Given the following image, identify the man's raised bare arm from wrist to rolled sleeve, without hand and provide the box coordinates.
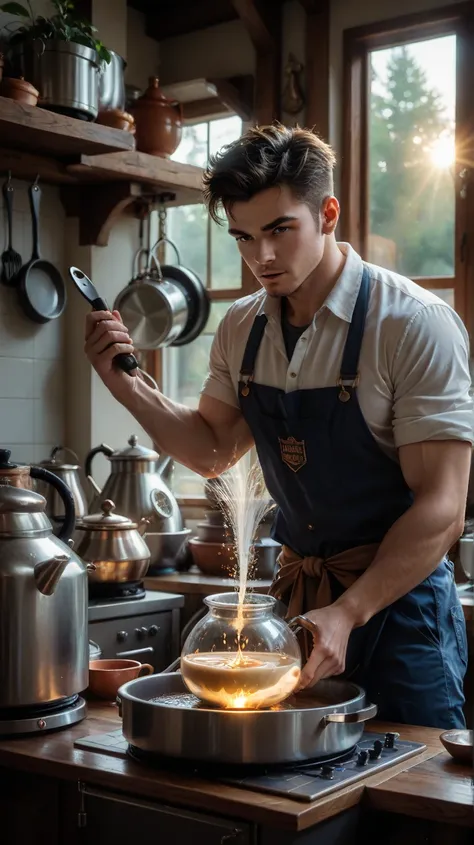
[123,379,253,478]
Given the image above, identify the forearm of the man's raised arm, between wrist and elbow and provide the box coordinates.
[120,378,219,476]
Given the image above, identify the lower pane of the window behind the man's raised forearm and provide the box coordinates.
[163,302,231,498]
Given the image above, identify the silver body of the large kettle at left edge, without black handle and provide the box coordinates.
[0,485,89,709]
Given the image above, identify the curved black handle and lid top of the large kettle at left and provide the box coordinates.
[0,449,76,542]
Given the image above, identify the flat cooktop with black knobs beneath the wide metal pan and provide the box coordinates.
[74,730,426,802]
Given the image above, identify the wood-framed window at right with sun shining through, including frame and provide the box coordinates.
[343,4,474,319]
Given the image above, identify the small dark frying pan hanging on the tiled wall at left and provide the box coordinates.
[16,177,66,323]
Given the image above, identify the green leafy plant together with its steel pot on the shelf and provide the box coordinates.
[0,0,110,120]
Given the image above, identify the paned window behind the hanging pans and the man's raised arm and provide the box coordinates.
[162,116,247,499]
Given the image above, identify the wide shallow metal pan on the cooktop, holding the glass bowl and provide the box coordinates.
[119,673,377,764]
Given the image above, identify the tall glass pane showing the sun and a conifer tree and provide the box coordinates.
[368,35,456,276]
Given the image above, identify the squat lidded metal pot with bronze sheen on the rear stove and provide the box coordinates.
[76,499,150,583]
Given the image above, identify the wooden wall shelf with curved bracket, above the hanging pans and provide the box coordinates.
[0,97,202,246]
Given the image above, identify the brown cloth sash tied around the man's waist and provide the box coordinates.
[269,543,379,619]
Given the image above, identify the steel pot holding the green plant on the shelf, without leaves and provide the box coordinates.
[9,39,101,120]
